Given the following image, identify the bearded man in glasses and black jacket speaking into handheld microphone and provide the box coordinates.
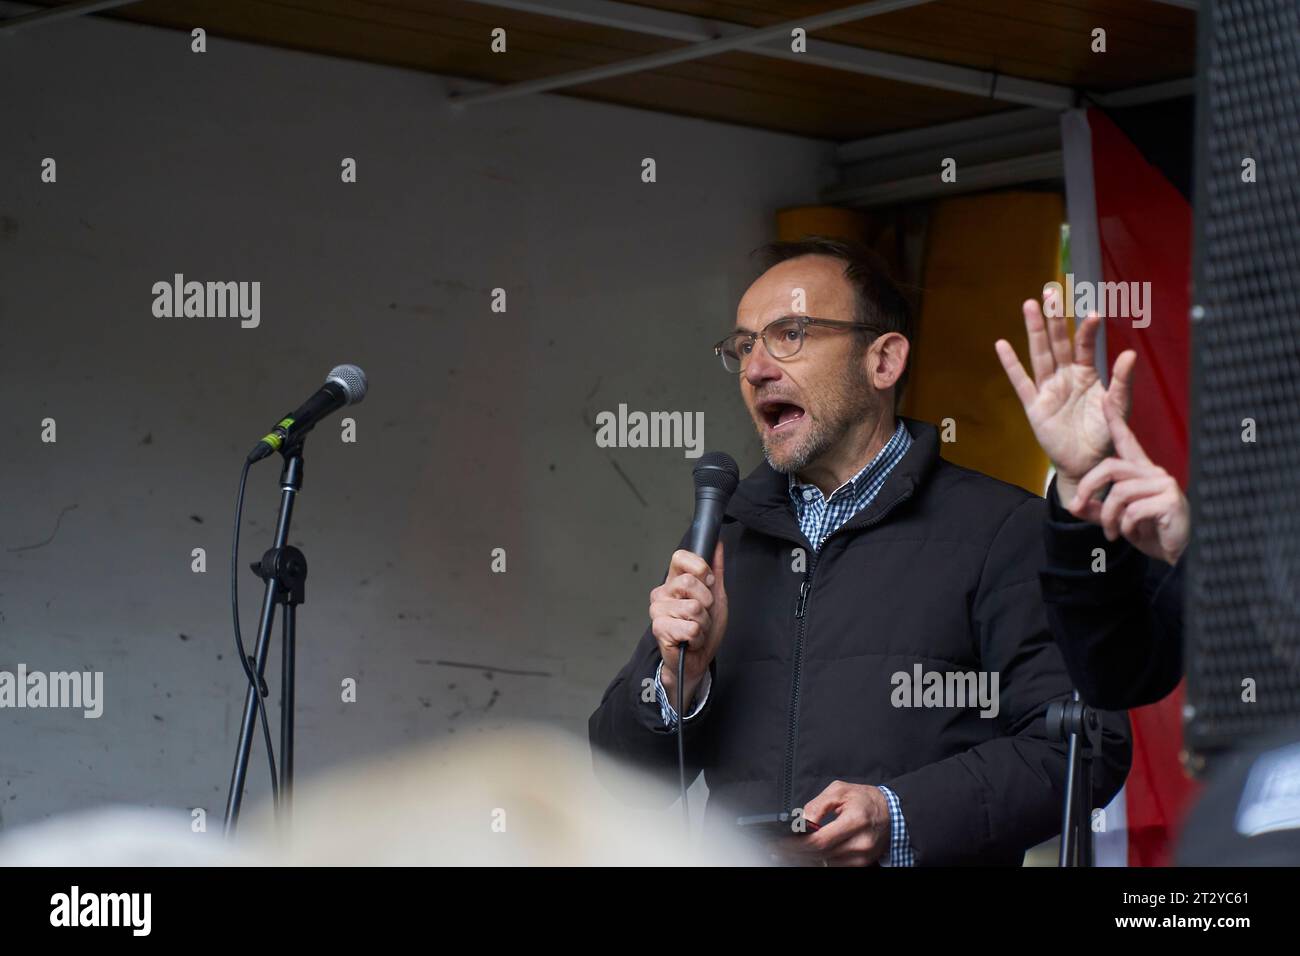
[589,237,1130,866]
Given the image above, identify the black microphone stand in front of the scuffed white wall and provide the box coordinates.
[225,432,307,836]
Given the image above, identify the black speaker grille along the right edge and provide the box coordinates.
[1186,0,1300,756]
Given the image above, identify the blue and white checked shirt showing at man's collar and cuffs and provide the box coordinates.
[654,421,917,866]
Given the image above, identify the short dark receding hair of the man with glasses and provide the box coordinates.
[754,235,913,405]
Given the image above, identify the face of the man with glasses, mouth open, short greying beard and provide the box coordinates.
[736,255,881,473]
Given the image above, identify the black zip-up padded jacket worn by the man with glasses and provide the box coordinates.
[589,419,1131,865]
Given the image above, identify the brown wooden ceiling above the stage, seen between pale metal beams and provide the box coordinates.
[14,0,1196,140]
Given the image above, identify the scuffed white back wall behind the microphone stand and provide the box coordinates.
[0,4,829,826]
